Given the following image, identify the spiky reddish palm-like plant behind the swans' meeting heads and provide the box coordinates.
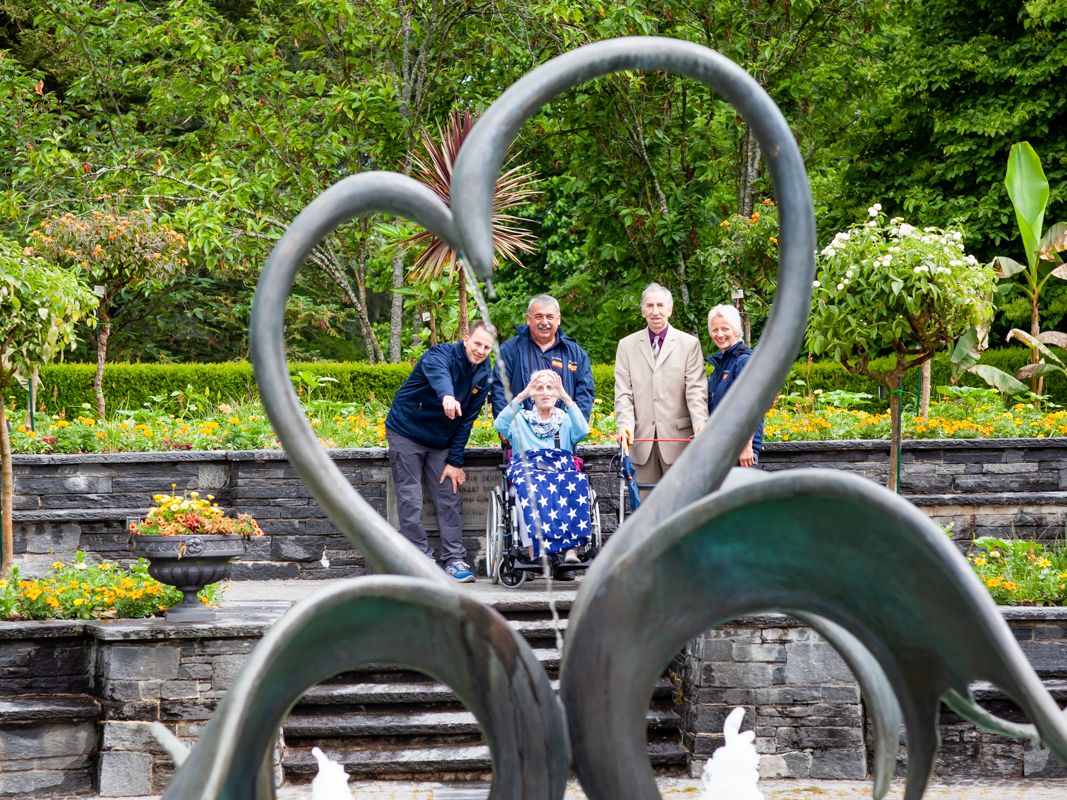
[400,111,539,343]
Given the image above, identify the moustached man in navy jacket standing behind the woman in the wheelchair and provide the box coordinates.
[492,294,593,420]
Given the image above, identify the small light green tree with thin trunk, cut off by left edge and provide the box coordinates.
[0,237,96,577]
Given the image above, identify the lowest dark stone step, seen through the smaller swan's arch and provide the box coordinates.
[282,741,686,780]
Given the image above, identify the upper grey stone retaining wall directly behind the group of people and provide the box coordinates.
[14,438,1067,580]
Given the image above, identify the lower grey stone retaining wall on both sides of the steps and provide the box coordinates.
[0,606,1067,798]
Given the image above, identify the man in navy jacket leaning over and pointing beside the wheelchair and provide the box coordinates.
[385,320,493,583]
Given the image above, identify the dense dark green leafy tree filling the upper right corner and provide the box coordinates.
[827,0,1067,260]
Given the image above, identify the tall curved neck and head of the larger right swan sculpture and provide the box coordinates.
[451,36,815,550]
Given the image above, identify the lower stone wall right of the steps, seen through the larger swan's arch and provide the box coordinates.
[674,608,1067,780]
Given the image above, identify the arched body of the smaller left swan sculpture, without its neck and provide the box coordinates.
[163,576,570,800]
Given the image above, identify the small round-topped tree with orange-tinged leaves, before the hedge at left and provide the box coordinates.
[30,210,189,417]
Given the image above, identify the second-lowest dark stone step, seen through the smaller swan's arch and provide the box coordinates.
[284,708,679,745]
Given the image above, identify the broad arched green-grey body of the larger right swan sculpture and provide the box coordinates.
[561,469,1067,800]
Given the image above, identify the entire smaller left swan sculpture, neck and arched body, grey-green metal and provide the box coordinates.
[157,173,570,800]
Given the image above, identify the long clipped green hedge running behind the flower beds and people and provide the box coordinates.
[10,348,1067,415]
